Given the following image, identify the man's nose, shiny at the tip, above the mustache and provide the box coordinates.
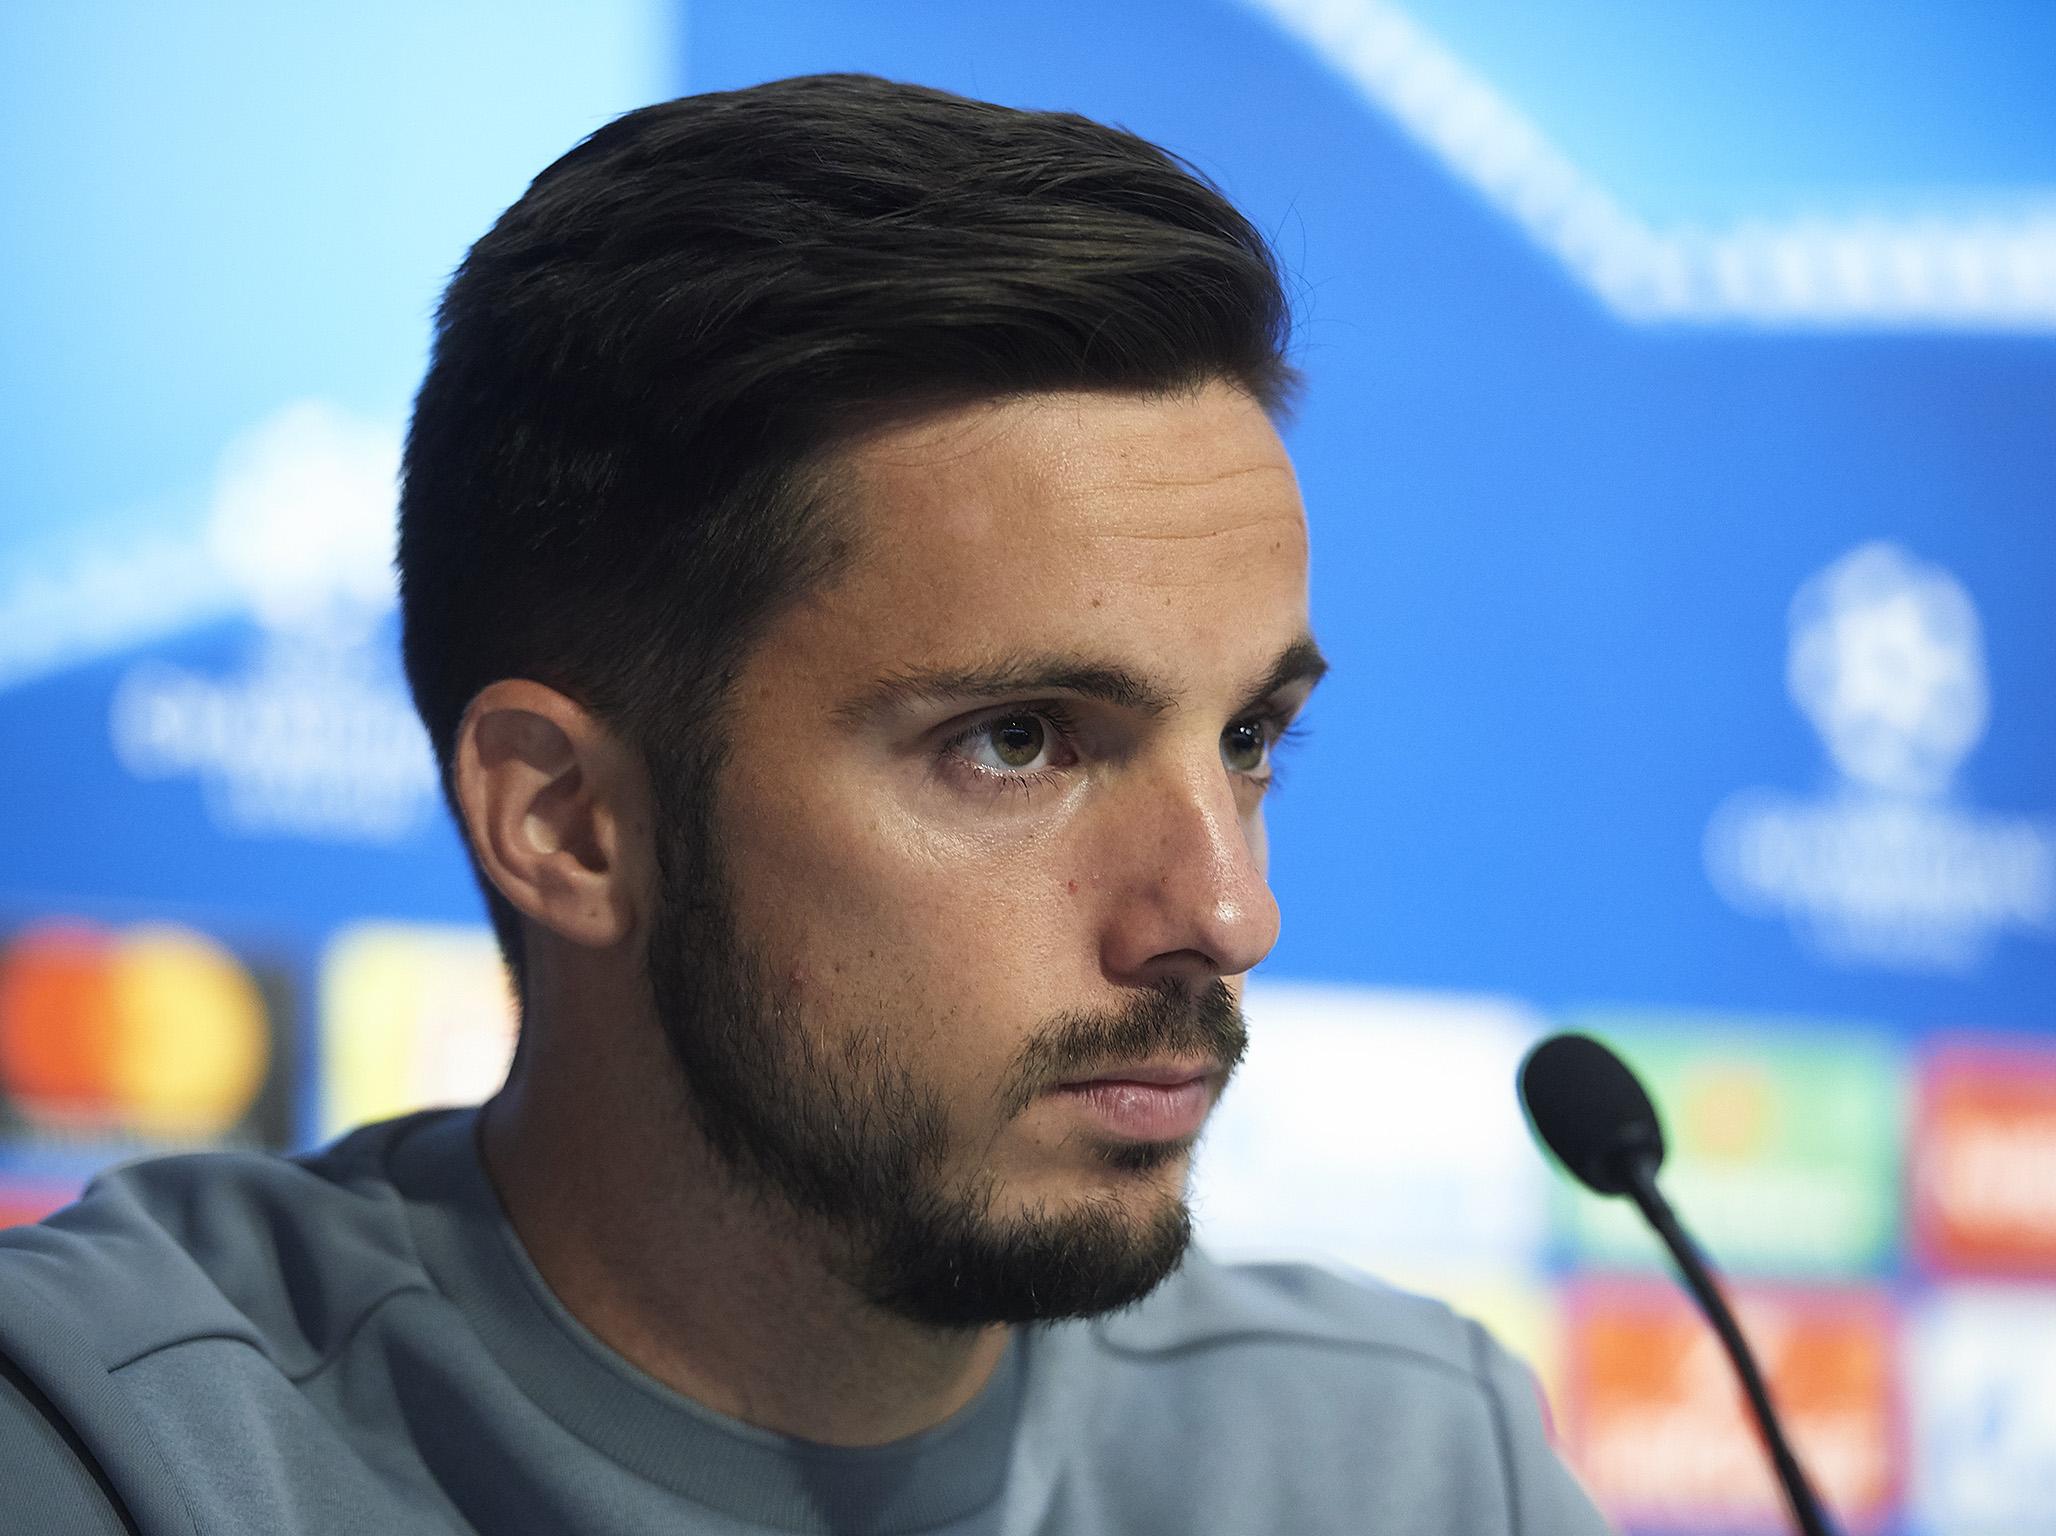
[1100,748,1279,987]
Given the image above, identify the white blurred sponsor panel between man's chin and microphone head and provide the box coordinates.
[1195,983,1548,1273]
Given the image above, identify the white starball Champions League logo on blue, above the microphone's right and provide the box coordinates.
[1706,543,2056,973]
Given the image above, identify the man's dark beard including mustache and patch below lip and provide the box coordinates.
[648,785,1246,1328]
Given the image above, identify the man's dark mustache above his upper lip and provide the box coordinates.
[990,977,1250,1114]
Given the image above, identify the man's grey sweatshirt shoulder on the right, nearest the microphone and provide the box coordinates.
[1032,1254,1606,1536]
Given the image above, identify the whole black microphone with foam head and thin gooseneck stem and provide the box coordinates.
[1519,1034,1834,1536]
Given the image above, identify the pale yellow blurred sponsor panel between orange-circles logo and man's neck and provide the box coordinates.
[321,923,516,1135]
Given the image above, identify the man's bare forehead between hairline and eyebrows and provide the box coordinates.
[802,385,1306,662]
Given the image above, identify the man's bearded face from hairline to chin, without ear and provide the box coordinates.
[650,385,1320,1324]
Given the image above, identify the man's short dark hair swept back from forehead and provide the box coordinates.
[399,74,1295,979]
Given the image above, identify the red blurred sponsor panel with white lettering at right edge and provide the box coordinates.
[1912,1043,2056,1274]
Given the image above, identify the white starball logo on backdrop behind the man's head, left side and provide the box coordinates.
[109,401,436,843]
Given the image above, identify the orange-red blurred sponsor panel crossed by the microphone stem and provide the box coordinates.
[1565,1281,1900,1530]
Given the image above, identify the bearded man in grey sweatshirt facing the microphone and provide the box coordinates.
[0,78,1600,1536]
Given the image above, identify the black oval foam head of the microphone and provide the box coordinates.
[1519,1034,1663,1195]
